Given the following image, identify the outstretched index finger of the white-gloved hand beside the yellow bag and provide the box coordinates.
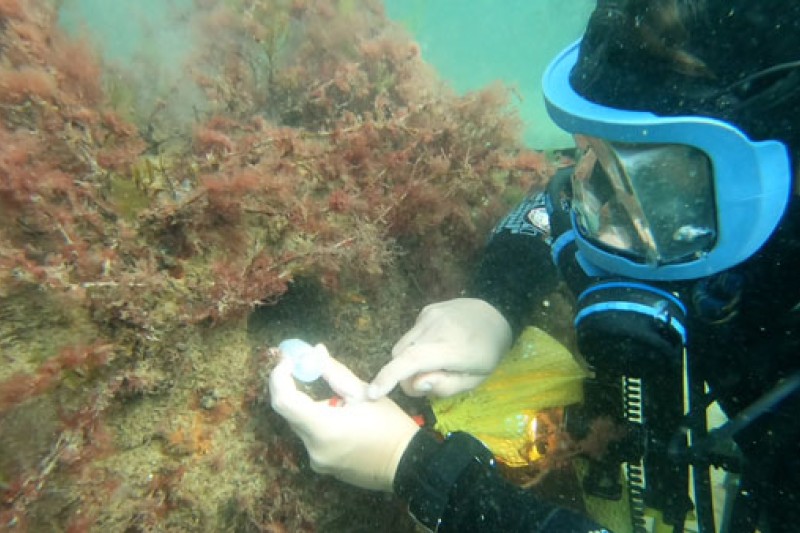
[367,342,469,400]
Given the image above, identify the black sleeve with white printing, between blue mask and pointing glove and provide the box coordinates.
[466,192,558,337]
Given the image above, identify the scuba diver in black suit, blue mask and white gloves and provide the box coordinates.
[270,0,800,533]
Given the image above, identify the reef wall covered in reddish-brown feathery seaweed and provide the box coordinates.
[0,0,551,532]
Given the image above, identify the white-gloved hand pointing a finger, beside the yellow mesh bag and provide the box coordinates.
[367,298,512,399]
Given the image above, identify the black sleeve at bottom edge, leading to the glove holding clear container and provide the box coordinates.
[394,430,608,533]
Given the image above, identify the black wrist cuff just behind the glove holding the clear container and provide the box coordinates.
[394,430,494,531]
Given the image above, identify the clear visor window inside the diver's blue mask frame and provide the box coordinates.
[572,135,717,265]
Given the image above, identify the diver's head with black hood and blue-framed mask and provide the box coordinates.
[544,0,800,280]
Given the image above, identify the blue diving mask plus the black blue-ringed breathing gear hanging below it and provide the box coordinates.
[543,38,791,529]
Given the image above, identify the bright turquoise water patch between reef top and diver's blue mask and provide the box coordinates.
[385,0,595,148]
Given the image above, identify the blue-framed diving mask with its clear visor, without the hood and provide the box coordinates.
[543,42,792,281]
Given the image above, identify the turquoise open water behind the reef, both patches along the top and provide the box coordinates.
[61,0,595,149]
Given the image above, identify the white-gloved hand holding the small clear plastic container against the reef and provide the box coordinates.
[269,344,419,492]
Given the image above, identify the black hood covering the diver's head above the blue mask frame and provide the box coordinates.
[570,0,800,154]
